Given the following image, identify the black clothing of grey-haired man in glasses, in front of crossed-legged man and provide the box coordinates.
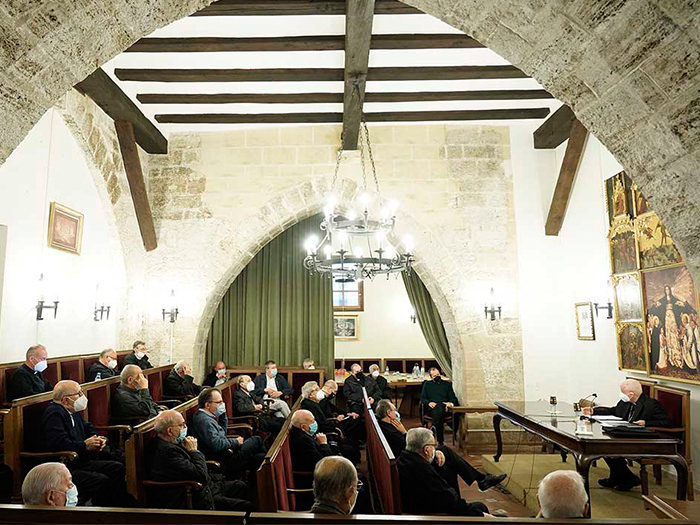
[396,450,488,516]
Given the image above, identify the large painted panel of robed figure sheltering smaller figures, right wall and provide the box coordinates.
[642,265,700,384]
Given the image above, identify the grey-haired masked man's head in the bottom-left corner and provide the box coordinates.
[22,463,78,507]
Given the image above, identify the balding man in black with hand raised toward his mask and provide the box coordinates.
[146,410,252,512]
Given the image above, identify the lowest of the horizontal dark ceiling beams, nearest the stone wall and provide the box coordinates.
[155,108,549,124]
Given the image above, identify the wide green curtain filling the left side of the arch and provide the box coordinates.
[207,215,334,370]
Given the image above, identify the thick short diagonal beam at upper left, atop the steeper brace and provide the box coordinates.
[75,68,168,154]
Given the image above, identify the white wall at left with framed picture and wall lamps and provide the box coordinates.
[0,110,125,362]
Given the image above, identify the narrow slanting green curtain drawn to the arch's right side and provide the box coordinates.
[401,271,452,377]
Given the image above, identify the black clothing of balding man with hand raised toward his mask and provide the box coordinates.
[146,437,252,511]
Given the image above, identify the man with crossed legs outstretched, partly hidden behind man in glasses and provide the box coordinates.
[375,399,507,494]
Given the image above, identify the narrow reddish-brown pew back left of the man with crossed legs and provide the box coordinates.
[362,388,401,514]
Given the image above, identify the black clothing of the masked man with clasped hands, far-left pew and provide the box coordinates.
[42,401,126,507]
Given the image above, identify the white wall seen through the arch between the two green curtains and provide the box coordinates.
[335,277,432,359]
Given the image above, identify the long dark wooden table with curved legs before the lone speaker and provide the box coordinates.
[493,401,688,516]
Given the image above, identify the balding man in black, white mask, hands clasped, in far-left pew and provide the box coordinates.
[42,381,126,507]
